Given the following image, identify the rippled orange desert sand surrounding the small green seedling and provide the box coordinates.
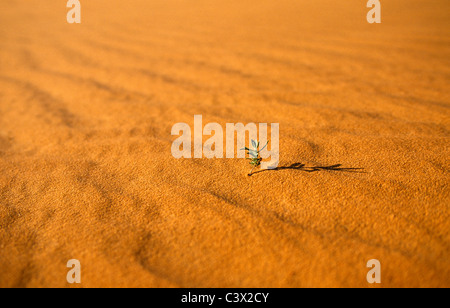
[0,0,450,287]
